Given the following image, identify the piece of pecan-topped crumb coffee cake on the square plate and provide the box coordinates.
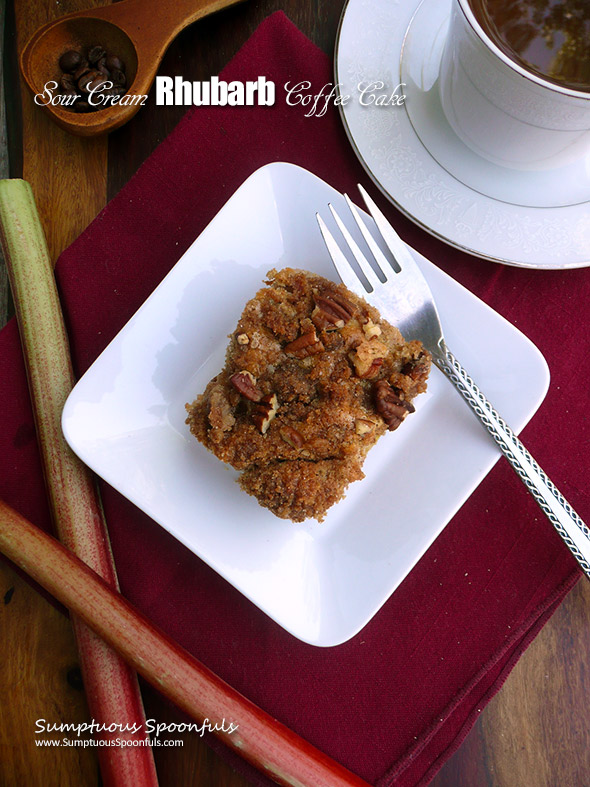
[187,268,431,522]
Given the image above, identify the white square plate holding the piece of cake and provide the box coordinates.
[63,163,549,646]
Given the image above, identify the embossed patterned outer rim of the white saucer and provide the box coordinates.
[335,0,590,269]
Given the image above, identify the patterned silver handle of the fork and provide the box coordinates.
[433,341,590,579]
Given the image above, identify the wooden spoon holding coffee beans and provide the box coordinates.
[21,0,247,136]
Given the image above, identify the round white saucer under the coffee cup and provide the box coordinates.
[335,0,590,269]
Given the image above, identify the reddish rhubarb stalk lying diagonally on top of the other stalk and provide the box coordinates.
[0,501,368,787]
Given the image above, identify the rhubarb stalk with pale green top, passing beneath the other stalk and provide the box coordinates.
[0,180,157,787]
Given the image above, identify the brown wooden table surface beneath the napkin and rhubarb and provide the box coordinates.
[0,0,590,787]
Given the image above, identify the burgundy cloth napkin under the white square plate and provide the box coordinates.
[0,13,590,787]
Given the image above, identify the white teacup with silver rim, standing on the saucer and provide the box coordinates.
[439,0,590,170]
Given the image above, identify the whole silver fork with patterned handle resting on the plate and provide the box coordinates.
[316,185,590,579]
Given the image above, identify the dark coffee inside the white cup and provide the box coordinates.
[469,0,590,92]
